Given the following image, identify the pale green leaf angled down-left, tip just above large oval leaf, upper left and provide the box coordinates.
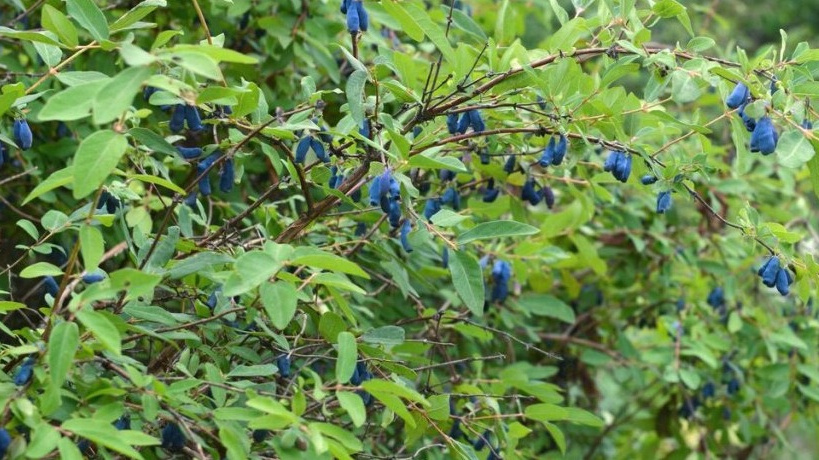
[93,67,154,125]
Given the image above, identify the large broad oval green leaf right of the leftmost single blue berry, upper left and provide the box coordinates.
[73,129,128,198]
